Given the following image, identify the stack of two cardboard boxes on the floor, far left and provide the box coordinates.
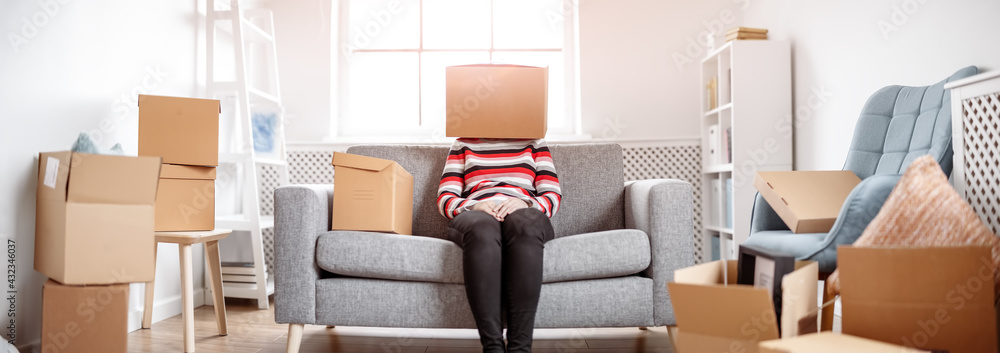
[35,151,160,352]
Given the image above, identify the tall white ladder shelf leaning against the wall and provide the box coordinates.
[205,0,288,309]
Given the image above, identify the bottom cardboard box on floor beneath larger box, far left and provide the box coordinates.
[41,279,128,353]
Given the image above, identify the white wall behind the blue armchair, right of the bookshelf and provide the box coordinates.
[743,0,1000,170]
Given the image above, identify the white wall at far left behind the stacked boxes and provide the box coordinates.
[0,0,201,346]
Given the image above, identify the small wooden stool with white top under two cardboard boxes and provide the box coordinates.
[142,229,232,353]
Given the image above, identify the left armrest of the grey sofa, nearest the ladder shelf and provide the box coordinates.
[274,185,333,324]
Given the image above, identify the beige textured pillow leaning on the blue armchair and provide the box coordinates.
[827,155,1000,294]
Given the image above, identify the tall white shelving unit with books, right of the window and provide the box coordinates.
[700,40,794,261]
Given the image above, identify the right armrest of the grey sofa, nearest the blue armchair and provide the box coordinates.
[625,179,694,326]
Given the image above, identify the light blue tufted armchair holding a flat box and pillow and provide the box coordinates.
[746,66,979,330]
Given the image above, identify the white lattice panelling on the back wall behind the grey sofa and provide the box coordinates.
[282,145,704,261]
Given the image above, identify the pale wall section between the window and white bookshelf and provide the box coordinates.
[579,0,746,139]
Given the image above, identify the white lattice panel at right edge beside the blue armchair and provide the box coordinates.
[956,93,1000,233]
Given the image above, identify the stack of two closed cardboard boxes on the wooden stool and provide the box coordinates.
[139,95,220,231]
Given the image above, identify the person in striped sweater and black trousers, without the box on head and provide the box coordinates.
[437,138,562,353]
